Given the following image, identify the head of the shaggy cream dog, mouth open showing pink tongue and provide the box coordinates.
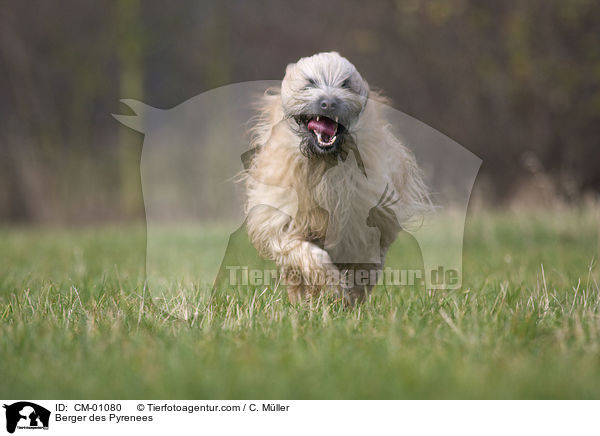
[281,52,369,156]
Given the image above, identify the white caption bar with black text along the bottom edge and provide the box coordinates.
[0,400,600,436]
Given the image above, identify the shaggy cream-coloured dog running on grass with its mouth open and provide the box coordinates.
[244,52,430,303]
